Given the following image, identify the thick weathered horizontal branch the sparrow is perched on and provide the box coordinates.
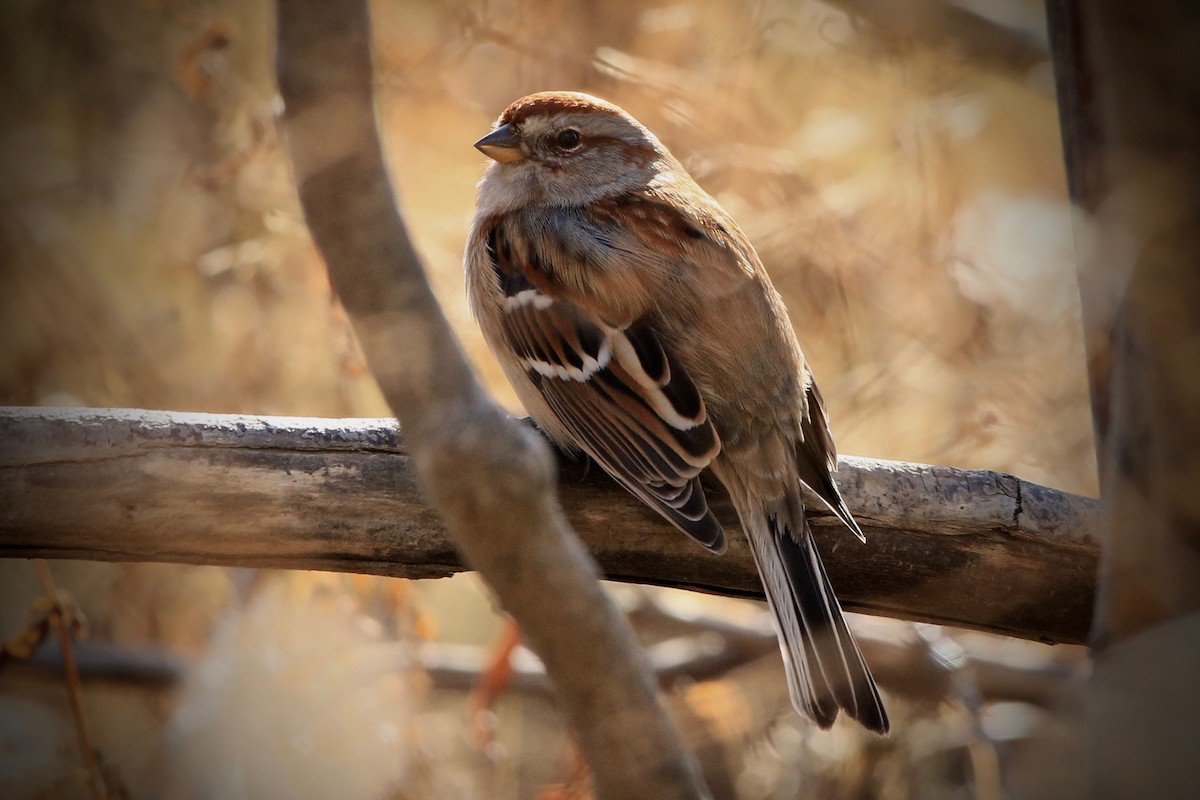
[0,408,1100,644]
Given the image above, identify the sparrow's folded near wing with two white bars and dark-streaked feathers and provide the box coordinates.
[488,220,725,552]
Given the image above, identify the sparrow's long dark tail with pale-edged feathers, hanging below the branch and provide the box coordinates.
[742,501,888,734]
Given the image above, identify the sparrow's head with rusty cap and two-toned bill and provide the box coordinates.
[475,91,678,207]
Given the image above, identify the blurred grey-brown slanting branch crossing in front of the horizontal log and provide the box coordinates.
[276,0,707,800]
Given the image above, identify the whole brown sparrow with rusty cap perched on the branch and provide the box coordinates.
[466,92,888,733]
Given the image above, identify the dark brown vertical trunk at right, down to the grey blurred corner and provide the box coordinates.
[1050,0,1200,640]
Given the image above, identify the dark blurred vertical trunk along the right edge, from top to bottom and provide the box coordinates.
[1050,0,1200,798]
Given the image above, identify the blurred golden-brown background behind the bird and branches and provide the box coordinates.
[0,0,1097,799]
